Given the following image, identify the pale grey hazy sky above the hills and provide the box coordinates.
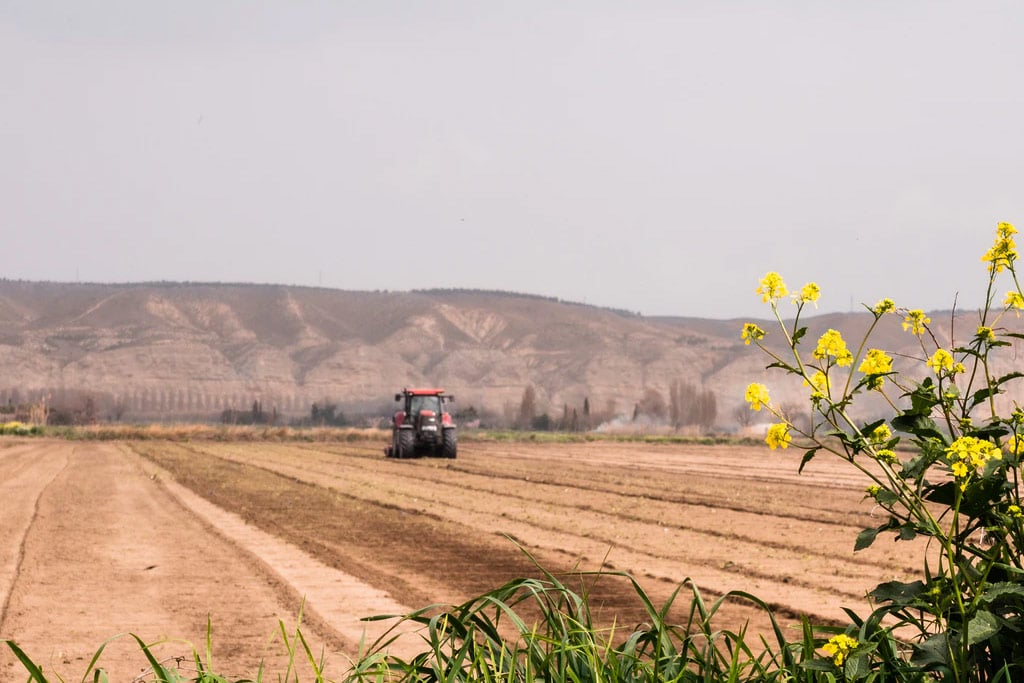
[0,0,1024,318]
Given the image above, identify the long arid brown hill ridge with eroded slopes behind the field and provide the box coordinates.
[0,282,1020,430]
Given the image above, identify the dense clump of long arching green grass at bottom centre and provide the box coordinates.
[346,569,814,683]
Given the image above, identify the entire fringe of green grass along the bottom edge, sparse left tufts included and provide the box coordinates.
[5,552,888,683]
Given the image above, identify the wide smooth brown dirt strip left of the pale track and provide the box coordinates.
[0,441,343,681]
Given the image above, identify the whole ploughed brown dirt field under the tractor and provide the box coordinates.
[0,439,923,681]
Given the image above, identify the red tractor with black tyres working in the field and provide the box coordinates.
[384,387,459,458]
